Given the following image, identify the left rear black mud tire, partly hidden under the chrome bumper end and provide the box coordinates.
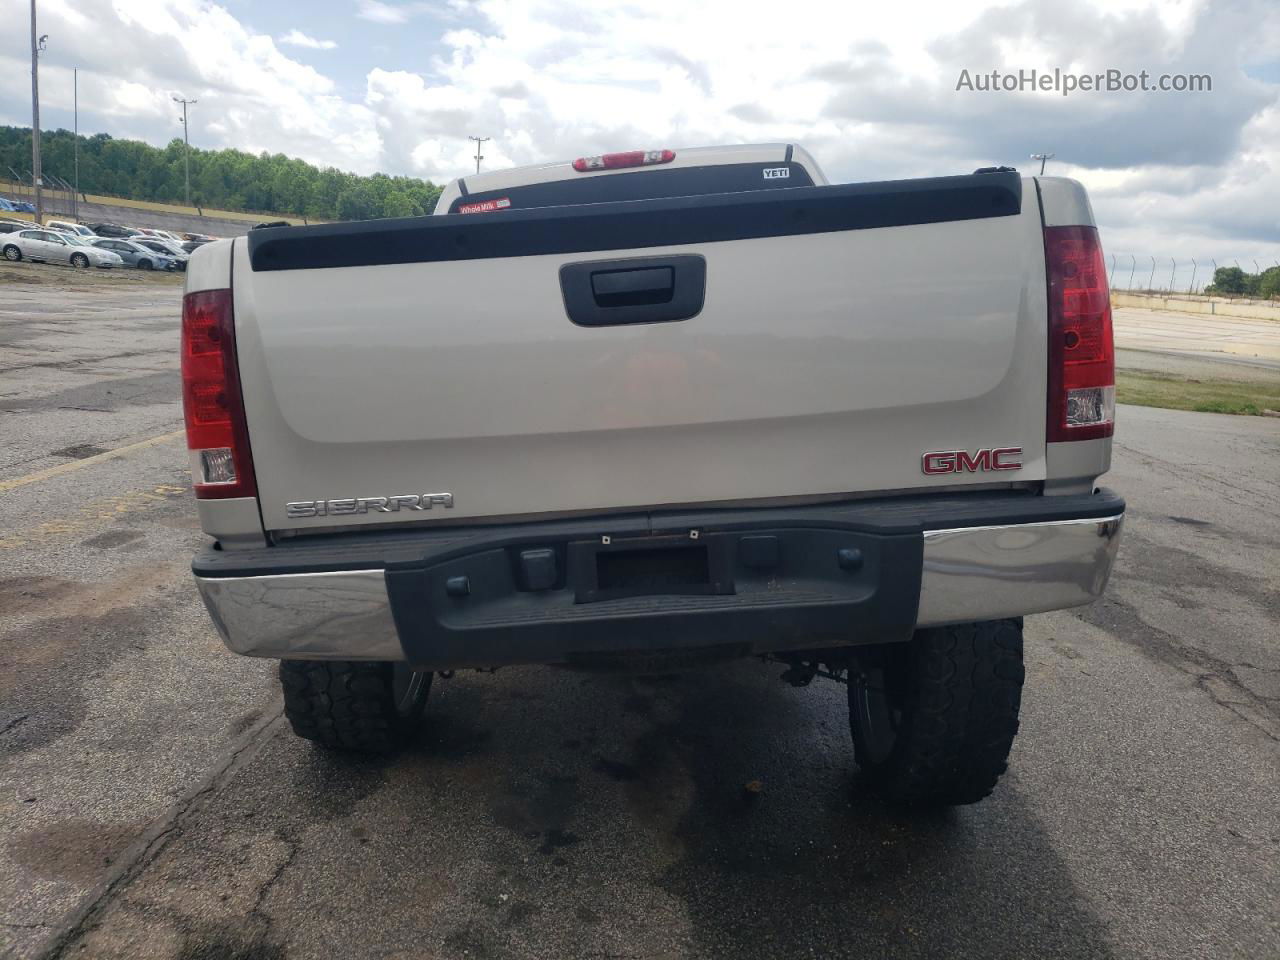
[280,660,431,754]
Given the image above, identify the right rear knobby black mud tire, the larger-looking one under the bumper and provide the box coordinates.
[849,620,1025,808]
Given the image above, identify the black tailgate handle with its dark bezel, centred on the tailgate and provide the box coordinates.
[561,255,707,326]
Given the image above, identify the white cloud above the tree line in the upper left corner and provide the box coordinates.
[0,0,380,173]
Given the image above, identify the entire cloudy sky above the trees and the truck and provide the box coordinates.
[0,0,1280,269]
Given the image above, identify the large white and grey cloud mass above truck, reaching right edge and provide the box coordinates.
[366,0,1280,257]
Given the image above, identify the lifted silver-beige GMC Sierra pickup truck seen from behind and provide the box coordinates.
[182,145,1124,805]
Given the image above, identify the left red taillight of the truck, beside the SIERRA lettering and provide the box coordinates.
[182,291,257,499]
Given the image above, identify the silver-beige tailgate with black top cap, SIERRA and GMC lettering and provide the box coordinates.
[233,174,1046,530]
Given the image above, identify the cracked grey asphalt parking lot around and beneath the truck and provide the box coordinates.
[0,265,1280,960]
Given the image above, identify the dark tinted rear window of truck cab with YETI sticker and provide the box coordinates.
[449,161,813,214]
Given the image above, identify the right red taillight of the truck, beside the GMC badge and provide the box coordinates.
[1044,227,1116,443]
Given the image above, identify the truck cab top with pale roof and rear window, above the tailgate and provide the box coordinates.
[435,143,827,214]
